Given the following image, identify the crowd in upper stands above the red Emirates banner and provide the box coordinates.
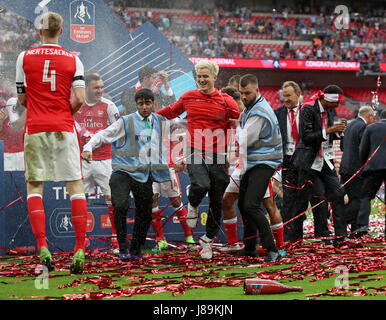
[111,1,386,61]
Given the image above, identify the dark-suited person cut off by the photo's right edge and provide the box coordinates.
[354,110,386,235]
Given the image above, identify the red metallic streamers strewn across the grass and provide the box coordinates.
[0,231,386,300]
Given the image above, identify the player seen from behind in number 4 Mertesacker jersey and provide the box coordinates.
[16,12,87,273]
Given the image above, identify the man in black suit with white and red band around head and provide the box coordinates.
[292,85,349,245]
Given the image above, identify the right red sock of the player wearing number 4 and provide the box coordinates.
[71,194,87,252]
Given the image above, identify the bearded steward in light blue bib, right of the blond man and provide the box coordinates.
[237,74,283,262]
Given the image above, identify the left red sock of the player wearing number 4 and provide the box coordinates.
[27,193,48,251]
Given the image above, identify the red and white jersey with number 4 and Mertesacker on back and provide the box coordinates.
[16,44,85,134]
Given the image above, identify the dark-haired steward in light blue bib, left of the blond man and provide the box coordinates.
[82,88,170,261]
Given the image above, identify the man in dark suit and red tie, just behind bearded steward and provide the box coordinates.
[274,81,330,242]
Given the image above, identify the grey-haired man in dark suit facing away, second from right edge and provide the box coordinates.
[339,106,375,231]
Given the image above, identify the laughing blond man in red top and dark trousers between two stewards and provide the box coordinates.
[157,60,240,259]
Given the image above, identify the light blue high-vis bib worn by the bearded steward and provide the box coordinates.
[240,96,283,170]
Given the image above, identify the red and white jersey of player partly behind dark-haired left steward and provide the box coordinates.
[74,97,119,160]
